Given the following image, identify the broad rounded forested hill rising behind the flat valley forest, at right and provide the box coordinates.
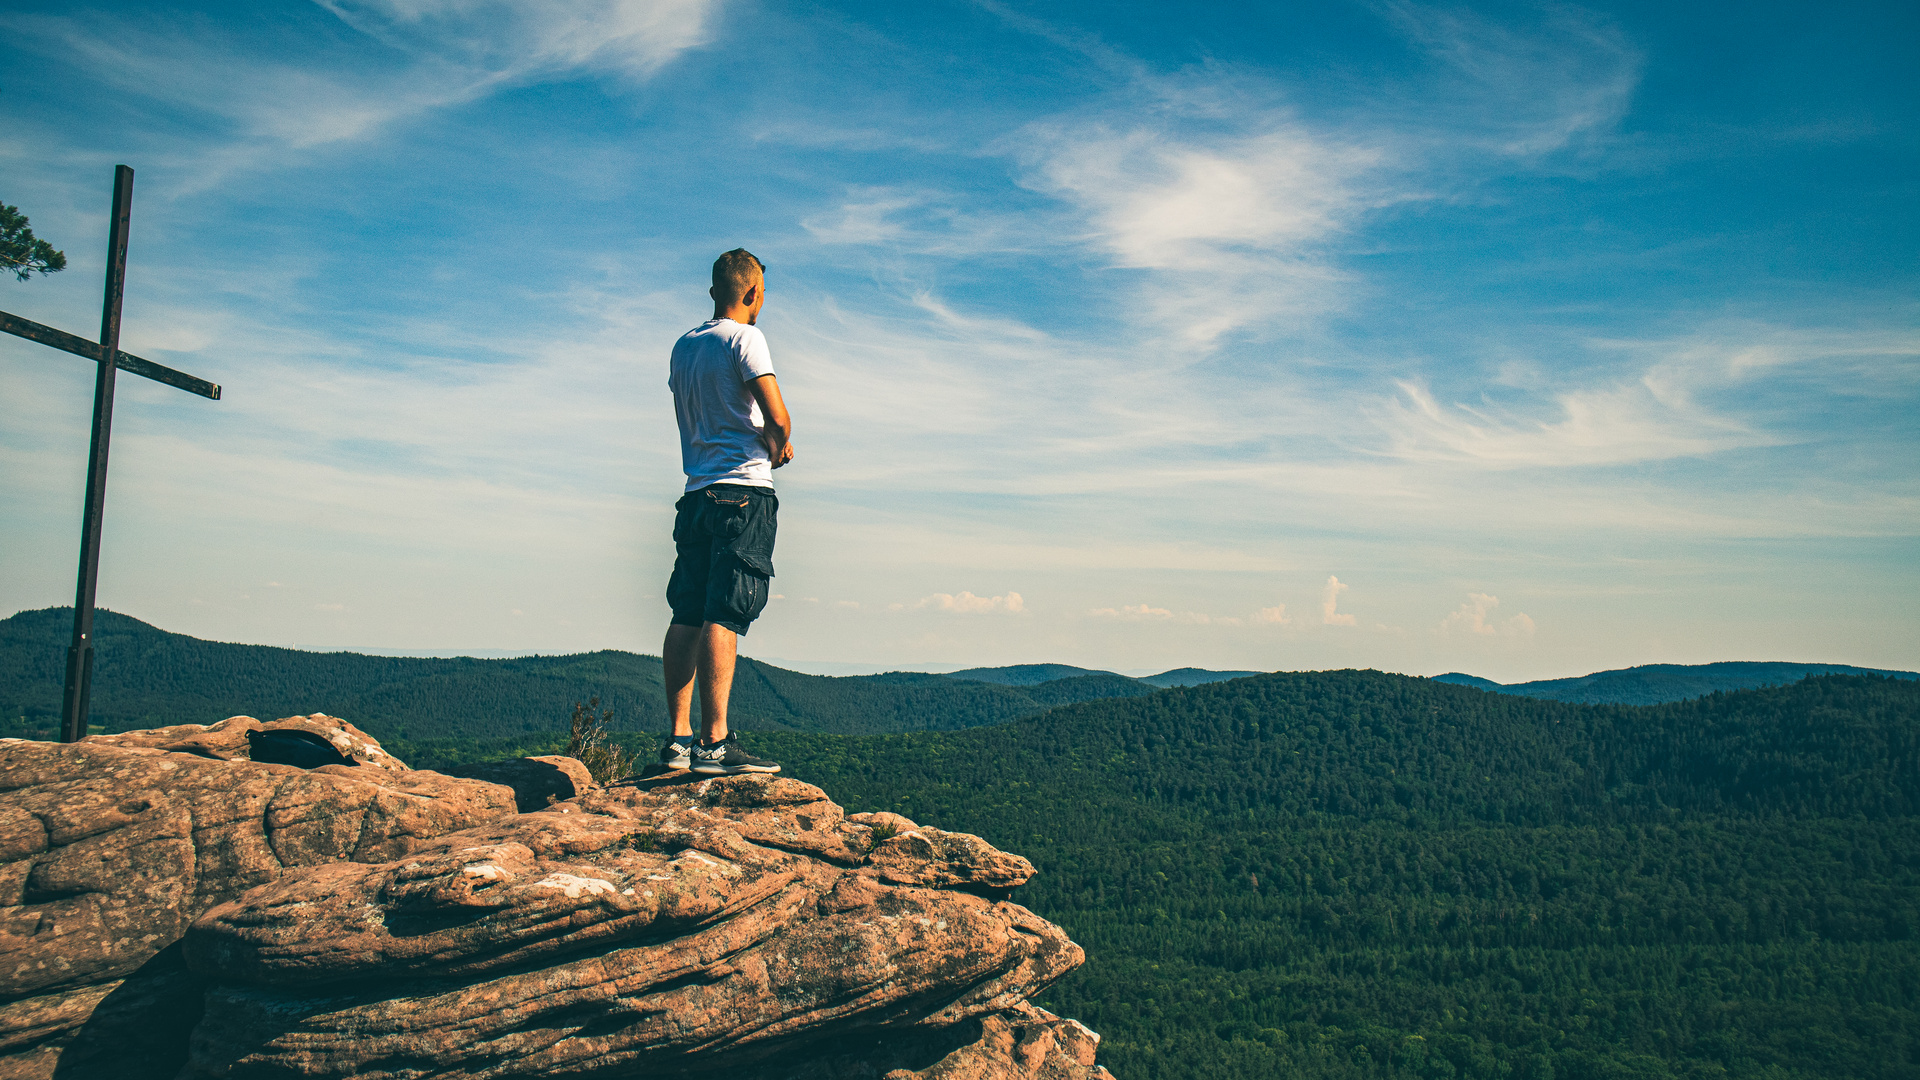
[768,671,1920,826]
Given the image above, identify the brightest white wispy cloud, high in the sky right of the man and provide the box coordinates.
[1000,2,1642,352]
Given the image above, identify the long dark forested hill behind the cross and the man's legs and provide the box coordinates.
[0,607,1154,740]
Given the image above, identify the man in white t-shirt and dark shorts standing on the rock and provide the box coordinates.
[660,248,793,774]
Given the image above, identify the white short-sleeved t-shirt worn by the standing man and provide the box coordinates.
[666,319,774,492]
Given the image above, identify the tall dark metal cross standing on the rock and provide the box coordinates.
[0,165,221,742]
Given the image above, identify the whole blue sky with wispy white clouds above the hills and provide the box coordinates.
[0,0,1920,680]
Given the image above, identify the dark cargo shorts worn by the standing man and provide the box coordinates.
[666,484,780,634]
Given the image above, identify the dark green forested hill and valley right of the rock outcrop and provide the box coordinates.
[737,671,1920,1080]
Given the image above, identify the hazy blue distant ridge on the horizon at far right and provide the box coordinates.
[1432,661,1920,705]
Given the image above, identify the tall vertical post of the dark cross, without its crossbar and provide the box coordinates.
[60,165,132,742]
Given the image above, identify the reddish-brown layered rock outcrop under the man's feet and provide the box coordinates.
[0,715,1106,1080]
